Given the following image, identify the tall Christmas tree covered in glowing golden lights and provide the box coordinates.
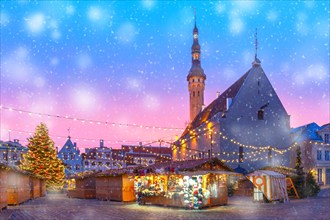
[20,123,65,190]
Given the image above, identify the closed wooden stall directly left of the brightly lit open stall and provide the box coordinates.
[96,169,135,202]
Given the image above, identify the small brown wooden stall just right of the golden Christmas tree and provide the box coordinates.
[67,172,96,199]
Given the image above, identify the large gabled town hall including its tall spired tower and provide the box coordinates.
[173,19,291,171]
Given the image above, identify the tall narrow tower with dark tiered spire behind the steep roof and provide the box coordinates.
[187,13,206,122]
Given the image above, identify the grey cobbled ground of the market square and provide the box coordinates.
[0,187,330,220]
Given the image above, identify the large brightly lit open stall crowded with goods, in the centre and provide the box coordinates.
[134,158,240,209]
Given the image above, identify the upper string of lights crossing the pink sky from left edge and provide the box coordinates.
[0,106,183,132]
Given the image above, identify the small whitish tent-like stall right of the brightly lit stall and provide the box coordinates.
[247,170,289,202]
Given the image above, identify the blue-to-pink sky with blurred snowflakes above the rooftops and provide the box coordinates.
[0,0,330,149]
